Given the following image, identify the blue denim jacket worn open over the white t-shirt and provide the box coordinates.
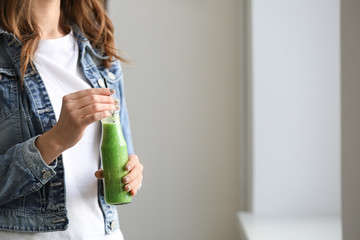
[0,27,134,234]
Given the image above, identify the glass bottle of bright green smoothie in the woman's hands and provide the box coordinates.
[101,114,131,204]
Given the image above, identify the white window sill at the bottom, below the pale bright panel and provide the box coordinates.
[238,213,342,240]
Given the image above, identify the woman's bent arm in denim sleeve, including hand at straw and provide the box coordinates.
[0,88,119,206]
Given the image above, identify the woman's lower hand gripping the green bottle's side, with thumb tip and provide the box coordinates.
[95,155,144,196]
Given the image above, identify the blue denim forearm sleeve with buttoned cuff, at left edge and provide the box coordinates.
[0,137,56,206]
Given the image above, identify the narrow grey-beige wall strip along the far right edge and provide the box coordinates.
[341,0,360,240]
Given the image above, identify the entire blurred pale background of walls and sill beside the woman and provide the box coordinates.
[107,0,360,240]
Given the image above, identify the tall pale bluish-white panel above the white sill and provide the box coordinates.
[251,0,340,214]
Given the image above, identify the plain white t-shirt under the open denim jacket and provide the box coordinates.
[1,34,123,240]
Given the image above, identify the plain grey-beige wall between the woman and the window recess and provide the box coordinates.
[109,0,239,240]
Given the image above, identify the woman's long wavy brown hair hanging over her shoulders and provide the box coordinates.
[0,0,129,85]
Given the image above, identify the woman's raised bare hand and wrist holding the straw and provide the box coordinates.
[35,88,120,164]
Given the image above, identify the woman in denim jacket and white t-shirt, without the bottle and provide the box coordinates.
[0,0,143,240]
